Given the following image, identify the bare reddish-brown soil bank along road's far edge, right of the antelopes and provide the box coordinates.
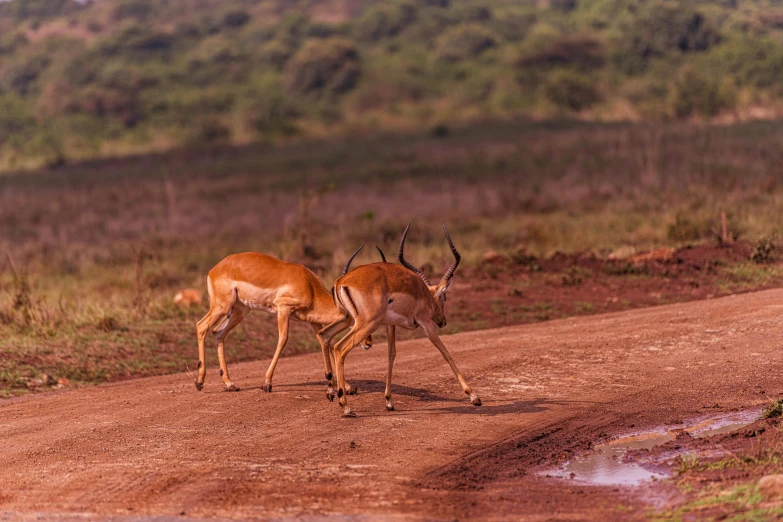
[444,242,764,329]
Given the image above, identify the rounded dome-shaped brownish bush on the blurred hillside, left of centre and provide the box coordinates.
[285,38,360,96]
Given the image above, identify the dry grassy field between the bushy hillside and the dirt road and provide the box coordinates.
[0,118,783,396]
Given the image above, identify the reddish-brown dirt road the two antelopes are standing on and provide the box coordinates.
[0,290,783,520]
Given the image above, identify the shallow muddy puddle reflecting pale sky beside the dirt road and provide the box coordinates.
[546,409,760,486]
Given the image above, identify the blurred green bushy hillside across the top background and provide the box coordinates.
[0,0,783,170]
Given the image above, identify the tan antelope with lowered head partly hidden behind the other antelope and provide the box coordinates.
[195,248,383,392]
